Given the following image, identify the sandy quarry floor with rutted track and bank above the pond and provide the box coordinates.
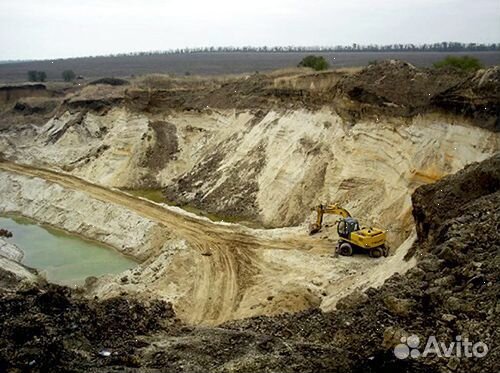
[0,158,424,324]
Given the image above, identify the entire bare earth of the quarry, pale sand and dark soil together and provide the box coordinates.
[0,61,500,372]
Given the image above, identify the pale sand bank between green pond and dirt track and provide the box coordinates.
[0,172,168,259]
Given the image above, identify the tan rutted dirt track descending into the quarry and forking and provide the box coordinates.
[0,161,331,324]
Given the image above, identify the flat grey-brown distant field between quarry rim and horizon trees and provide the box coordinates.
[0,52,500,82]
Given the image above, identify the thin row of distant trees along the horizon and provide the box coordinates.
[95,42,500,57]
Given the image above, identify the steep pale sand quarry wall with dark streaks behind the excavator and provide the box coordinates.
[0,108,500,247]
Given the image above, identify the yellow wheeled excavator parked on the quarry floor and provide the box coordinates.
[309,204,389,258]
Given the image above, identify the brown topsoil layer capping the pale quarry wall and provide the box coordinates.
[0,60,500,131]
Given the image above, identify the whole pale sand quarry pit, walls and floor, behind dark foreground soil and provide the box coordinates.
[0,62,500,325]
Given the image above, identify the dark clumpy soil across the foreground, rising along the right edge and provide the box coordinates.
[0,154,500,373]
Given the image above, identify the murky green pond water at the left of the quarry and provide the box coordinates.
[0,216,137,286]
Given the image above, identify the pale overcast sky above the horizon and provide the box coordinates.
[0,0,500,60]
